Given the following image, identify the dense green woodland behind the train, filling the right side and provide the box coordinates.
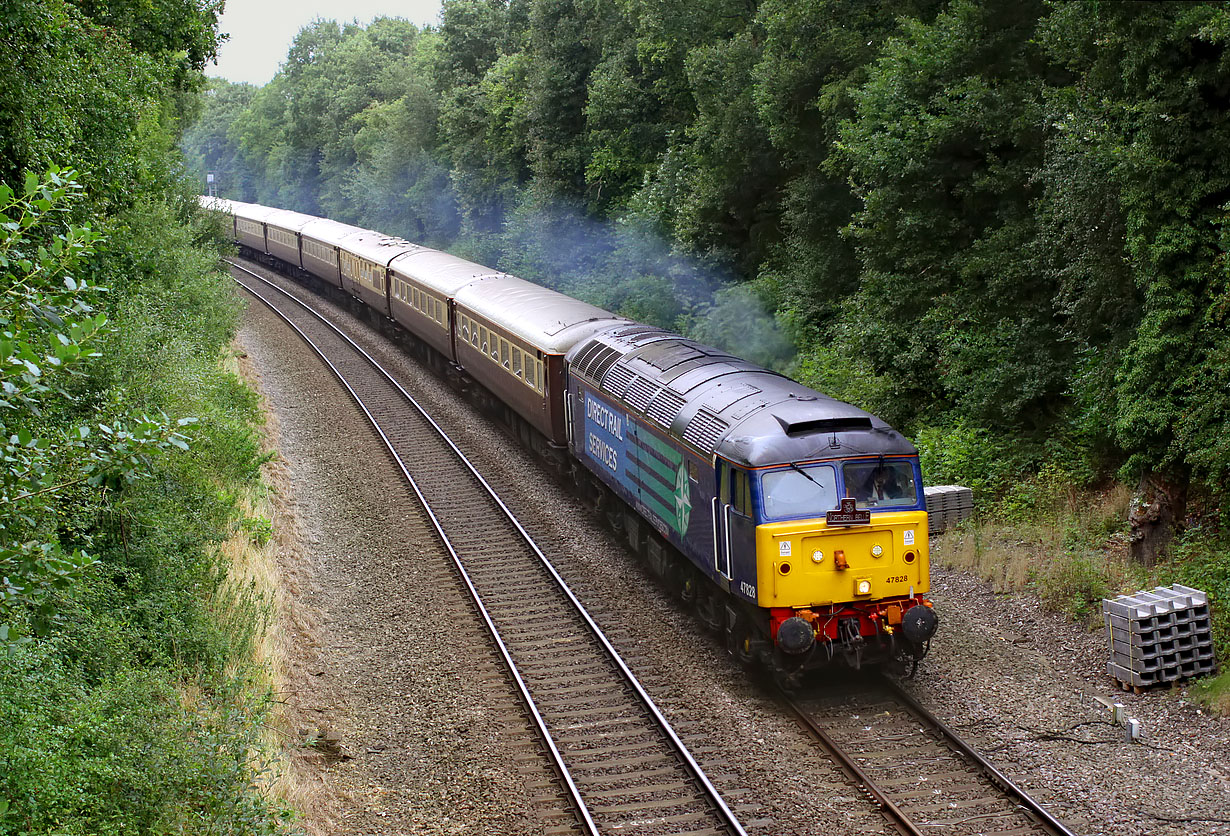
[179,0,1230,555]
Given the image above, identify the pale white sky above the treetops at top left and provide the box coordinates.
[205,0,440,85]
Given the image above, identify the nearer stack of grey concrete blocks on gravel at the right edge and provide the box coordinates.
[1102,584,1216,690]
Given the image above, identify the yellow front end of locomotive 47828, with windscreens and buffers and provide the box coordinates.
[755,456,937,668]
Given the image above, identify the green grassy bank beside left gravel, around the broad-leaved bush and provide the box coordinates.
[0,203,300,836]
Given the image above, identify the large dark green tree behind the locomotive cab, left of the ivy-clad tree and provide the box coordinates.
[841,0,1070,429]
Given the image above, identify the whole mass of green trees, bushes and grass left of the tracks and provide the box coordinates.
[0,0,291,835]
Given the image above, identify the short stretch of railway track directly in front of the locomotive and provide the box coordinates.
[785,675,1074,836]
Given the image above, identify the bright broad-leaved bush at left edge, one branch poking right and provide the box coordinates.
[0,167,194,648]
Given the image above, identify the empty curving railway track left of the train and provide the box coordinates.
[230,263,744,836]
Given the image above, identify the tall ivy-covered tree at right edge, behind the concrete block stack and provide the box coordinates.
[1044,2,1230,562]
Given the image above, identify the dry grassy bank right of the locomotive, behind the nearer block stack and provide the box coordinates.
[934,468,1230,713]
